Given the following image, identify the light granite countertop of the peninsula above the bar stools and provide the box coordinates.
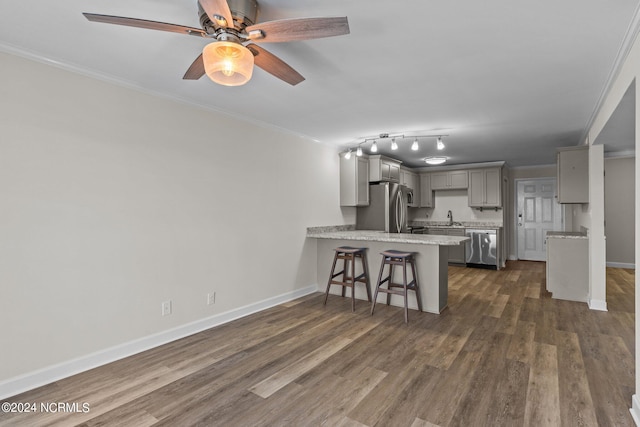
[307,227,470,246]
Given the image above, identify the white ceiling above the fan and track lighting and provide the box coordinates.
[0,0,640,166]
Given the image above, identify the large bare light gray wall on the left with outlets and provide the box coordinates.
[0,53,354,391]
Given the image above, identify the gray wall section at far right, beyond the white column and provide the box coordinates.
[604,157,635,267]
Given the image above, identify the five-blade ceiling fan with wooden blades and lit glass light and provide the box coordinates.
[83,0,349,86]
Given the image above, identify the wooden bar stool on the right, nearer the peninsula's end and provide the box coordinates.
[371,250,422,323]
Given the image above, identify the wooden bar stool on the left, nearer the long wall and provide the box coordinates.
[324,246,371,311]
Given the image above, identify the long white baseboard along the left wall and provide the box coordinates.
[0,285,318,399]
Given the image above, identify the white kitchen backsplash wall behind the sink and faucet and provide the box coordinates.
[409,190,503,222]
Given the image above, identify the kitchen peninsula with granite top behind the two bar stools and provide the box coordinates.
[307,226,469,314]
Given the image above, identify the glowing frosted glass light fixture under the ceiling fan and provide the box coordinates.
[202,41,253,86]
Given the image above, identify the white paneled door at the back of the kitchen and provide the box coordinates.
[516,178,562,261]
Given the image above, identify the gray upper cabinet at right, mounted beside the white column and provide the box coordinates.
[557,146,589,203]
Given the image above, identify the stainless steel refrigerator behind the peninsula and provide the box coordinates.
[356,182,409,233]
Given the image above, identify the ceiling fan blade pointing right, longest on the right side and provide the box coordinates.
[245,16,349,43]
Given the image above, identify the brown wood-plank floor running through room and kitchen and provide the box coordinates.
[0,262,635,427]
